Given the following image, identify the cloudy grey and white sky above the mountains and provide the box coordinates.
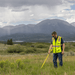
[0,0,75,27]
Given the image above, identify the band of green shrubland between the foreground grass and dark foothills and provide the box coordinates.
[0,42,75,55]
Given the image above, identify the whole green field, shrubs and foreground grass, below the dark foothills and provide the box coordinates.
[0,43,75,75]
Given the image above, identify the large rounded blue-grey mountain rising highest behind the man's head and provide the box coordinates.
[33,19,75,35]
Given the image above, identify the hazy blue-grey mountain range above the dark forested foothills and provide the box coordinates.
[3,19,75,34]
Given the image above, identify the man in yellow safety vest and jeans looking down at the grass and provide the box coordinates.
[48,31,65,68]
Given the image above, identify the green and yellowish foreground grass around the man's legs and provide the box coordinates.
[0,55,75,75]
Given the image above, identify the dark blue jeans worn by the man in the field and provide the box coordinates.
[53,53,63,67]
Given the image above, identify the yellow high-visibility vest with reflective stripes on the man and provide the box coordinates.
[52,36,62,53]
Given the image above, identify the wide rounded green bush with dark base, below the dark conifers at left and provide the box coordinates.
[7,45,24,53]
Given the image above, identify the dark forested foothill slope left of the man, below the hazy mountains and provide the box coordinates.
[0,33,51,42]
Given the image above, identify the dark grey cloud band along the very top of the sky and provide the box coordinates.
[0,0,62,7]
